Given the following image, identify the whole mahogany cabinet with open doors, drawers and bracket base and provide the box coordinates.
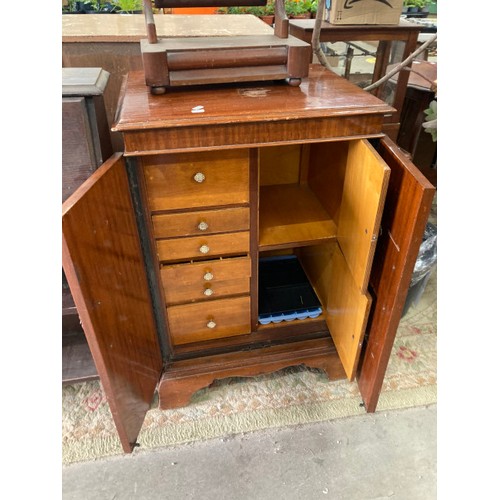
[63,65,434,452]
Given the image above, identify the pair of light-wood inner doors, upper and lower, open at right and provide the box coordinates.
[326,140,390,380]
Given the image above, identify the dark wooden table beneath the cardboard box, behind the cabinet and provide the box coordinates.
[290,19,423,141]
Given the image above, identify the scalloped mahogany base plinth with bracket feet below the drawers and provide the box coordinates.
[158,338,346,410]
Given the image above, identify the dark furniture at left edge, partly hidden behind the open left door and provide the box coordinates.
[62,68,112,383]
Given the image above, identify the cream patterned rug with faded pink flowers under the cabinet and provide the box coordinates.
[62,270,437,464]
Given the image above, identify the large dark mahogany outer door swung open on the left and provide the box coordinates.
[62,154,162,452]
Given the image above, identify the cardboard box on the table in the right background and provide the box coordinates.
[325,0,403,24]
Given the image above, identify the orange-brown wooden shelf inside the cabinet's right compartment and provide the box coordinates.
[259,184,337,250]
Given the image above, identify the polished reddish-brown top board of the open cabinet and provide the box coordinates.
[112,64,395,132]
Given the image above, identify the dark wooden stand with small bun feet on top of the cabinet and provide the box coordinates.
[141,0,311,94]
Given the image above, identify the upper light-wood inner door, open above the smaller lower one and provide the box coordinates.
[337,140,390,293]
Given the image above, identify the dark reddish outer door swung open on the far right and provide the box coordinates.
[357,138,435,412]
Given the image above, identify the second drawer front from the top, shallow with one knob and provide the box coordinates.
[152,207,250,238]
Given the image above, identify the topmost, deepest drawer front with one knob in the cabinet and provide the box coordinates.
[142,149,250,212]
